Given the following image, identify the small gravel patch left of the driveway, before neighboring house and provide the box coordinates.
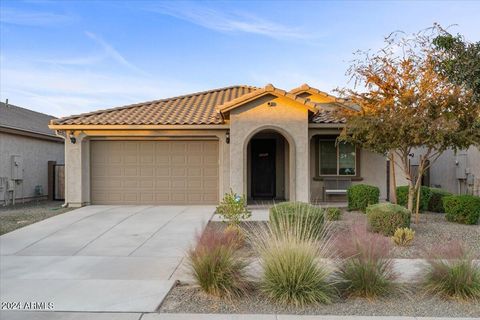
[0,201,72,235]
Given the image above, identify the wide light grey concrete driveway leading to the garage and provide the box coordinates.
[0,206,215,312]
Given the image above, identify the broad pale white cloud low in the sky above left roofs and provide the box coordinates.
[0,59,195,116]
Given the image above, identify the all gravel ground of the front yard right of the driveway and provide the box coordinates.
[159,202,480,317]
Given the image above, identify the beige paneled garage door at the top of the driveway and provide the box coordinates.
[90,141,219,204]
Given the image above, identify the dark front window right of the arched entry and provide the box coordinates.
[318,138,357,176]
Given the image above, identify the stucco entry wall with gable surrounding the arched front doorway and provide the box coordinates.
[230,96,310,201]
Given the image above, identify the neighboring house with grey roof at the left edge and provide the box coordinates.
[0,102,64,206]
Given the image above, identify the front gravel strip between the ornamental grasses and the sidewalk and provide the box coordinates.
[159,285,480,317]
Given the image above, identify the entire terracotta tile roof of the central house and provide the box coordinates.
[51,84,352,125]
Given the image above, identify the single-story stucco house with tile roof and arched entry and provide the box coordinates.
[49,84,398,206]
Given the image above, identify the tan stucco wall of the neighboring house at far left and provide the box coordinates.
[0,132,64,201]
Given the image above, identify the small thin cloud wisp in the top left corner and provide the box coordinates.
[0,7,77,27]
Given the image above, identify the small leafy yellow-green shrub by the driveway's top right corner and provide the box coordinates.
[216,190,252,226]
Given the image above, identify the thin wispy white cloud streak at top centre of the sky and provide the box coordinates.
[147,2,312,39]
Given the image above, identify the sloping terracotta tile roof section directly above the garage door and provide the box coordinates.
[52,85,258,125]
